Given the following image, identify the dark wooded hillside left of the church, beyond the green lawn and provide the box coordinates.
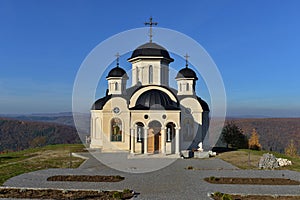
[0,118,80,152]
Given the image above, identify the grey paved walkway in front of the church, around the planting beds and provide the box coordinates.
[4,154,300,200]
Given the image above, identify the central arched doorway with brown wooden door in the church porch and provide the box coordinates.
[147,121,161,153]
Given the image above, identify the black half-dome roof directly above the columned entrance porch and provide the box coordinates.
[133,89,179,110]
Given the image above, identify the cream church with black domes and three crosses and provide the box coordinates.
[90,18,209,156]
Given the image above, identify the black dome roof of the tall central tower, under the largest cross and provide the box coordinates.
[129,42,174,62]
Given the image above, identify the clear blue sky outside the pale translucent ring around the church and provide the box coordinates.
[0,0,300,117]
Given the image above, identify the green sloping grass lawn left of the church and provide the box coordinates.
[0,144,84,185]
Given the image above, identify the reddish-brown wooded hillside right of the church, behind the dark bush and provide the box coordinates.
[227,118,300,153]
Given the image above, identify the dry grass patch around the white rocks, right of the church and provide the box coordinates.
[217,149,300,172]
